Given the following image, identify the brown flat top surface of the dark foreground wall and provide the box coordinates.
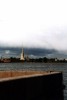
[0,71,60,79]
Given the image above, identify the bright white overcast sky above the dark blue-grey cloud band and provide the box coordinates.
[0,0,67,57]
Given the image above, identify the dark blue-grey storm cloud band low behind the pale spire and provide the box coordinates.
[0,47,67,58]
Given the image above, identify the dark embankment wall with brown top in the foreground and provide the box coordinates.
[0,71,64,100]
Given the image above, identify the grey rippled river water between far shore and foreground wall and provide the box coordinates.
[0,63,67,100]
